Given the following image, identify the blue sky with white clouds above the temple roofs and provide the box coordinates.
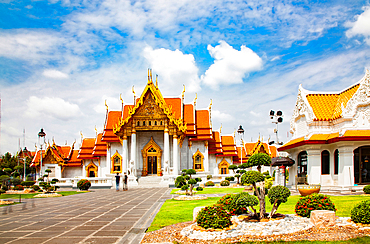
[0,0,370,153]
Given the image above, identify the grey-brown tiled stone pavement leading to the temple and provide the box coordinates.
[0,188,171,244]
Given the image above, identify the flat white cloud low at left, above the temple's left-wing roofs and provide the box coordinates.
[26,96,81,120]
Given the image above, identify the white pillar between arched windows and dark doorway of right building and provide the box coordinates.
[338,147,355,186]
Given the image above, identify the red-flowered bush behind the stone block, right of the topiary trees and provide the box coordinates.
[295,193,337,217]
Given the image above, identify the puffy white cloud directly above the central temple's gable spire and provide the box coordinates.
[143,46,200,93]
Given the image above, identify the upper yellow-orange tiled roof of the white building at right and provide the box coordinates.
[306,84,360,121]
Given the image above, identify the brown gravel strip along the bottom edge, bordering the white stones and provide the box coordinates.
[141,219,370,244]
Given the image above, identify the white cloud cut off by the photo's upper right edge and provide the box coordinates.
[346,7,370,45]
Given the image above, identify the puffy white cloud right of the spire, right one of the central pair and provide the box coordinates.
[201,41,262,89]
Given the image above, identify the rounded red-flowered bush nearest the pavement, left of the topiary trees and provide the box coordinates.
[196,204,232,229]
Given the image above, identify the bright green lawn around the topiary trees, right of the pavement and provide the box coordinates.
[148,193,370,232]
